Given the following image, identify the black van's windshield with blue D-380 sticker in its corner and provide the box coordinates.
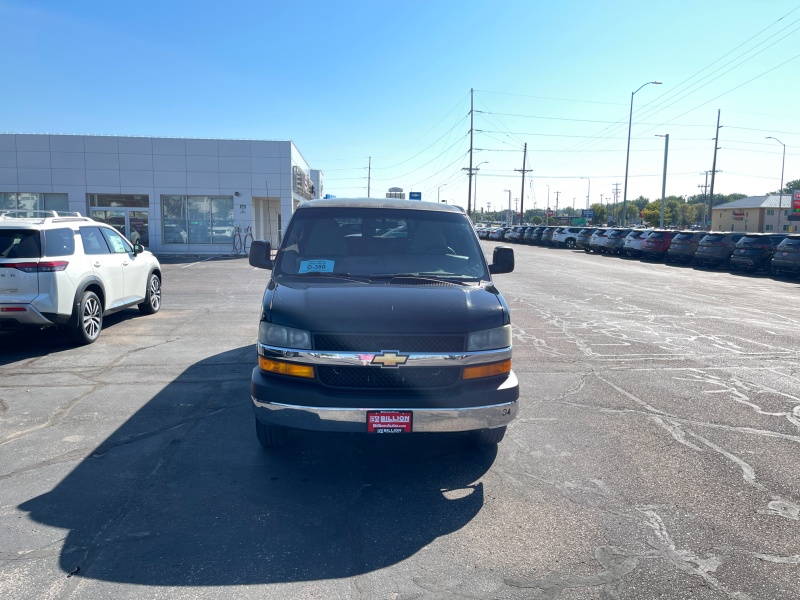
[274,207,489,280]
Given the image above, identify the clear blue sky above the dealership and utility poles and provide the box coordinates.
[0,0,800,216]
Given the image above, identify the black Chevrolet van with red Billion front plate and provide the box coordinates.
[249,198,519,448]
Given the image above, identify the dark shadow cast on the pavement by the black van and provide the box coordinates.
[20,346,497,586]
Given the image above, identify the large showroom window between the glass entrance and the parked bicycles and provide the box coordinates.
[161,195,234,244]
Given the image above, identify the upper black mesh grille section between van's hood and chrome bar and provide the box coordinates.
[314,334,466,352]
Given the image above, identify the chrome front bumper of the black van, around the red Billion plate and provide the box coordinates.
[251,396,517,433]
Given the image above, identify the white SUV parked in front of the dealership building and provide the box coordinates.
[0,211,161,345]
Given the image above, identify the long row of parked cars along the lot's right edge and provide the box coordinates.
[477,225,800,277]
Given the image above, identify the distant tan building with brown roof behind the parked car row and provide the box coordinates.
[711,194,800,233]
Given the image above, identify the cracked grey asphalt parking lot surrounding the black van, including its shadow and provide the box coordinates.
[0,242,800,600]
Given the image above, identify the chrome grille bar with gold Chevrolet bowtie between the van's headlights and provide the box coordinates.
[258,342,511,369]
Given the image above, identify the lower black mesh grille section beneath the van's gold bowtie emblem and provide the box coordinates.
[316,366,461,390]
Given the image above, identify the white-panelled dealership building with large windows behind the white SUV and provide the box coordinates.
[0,134,322,255]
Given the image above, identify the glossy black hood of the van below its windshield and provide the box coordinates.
[262,283,509,333]
